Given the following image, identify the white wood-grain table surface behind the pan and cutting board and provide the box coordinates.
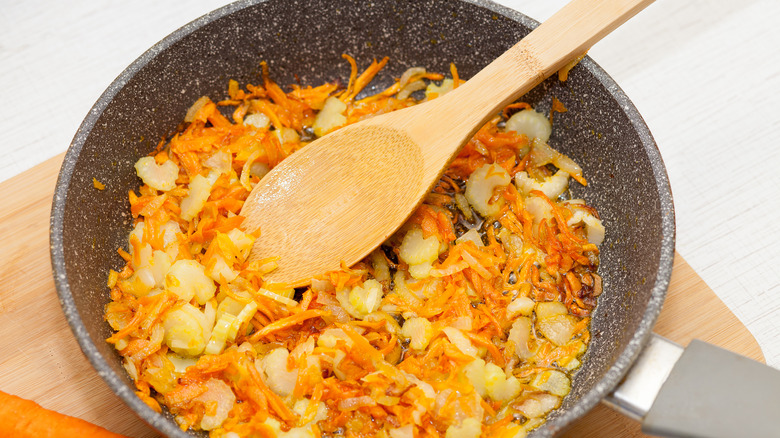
[0,0,780,368]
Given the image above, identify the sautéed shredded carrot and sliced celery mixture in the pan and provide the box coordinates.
[105,55,604,438]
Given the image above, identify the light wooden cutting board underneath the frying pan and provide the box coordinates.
[0,155,763,438]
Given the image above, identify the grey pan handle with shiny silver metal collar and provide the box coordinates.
[605,334,780,438]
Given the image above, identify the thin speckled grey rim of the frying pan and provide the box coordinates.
[49,0,675,438]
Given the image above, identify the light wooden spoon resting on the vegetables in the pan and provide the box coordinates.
[241,0,653,286]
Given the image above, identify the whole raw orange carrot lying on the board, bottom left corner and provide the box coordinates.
[0,391,129,438]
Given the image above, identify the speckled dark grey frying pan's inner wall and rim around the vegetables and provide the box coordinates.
[51,0,780,438]
